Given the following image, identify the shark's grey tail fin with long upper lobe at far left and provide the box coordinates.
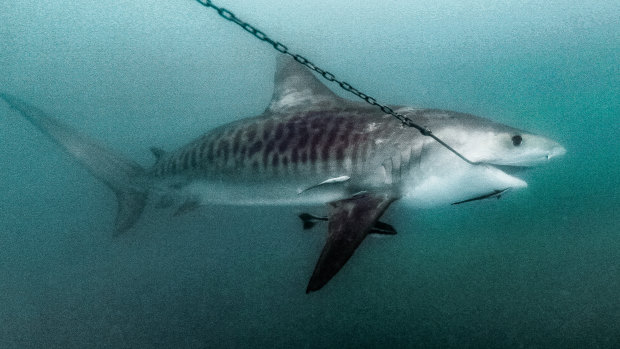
[0,93,148,234]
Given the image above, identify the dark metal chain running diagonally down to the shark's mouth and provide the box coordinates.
[196,0,478,165]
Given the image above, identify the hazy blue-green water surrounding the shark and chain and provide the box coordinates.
[0,0,620,348]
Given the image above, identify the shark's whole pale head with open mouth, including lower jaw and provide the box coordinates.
[405,109,566,206]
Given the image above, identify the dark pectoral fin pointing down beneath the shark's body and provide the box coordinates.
[306,193,396,293]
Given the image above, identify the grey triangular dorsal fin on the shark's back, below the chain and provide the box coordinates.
[268,55,345,113]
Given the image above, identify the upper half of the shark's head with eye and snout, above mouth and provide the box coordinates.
[429,112,566,167]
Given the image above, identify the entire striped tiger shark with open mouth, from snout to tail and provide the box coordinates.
[0,57,565,292]
